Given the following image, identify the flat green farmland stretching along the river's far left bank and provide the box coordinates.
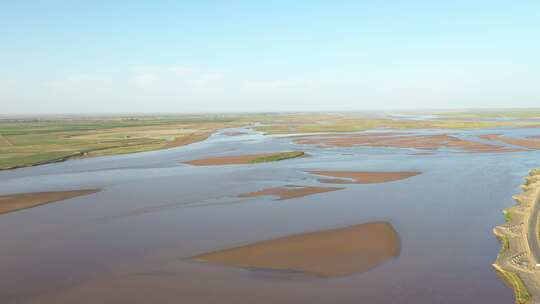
[0,116,239,169]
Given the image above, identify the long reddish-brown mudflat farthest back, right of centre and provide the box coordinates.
[295,133,517,152]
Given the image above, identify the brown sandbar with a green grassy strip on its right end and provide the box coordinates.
[184,151,306,166]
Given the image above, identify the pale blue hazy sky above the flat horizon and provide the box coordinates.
[0,0,540,114]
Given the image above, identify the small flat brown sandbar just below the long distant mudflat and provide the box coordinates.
[308,171,421,184]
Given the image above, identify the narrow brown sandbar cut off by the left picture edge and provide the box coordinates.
[0,189,100,214]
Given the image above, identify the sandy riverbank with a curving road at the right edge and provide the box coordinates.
[493,169,540,304]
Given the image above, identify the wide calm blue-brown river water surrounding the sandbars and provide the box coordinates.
[0,129,540,304]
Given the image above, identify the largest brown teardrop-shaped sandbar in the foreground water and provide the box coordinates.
[193,222,400,277]
